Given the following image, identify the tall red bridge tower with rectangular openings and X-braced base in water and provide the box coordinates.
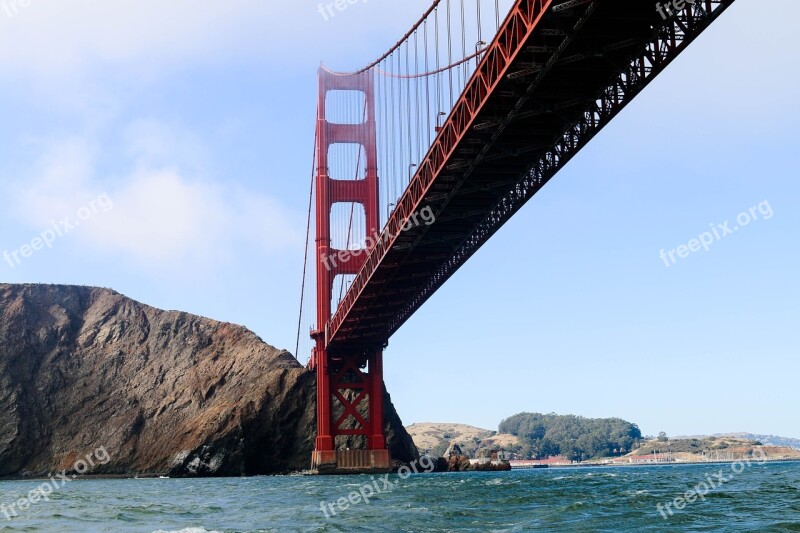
[311,68,391,473]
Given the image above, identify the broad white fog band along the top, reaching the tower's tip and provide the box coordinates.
[0,0,429,81]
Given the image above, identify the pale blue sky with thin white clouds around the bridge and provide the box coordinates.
[0,0,800,437]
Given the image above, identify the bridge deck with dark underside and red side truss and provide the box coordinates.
[327,0,733,354]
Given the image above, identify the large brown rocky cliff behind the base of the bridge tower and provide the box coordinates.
[0,284,418,476]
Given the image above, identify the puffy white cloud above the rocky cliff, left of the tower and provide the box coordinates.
[12,120,302,270]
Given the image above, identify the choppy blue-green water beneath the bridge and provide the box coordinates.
[0,463,800,533]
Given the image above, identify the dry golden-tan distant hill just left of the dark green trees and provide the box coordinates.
[406,422,519,456]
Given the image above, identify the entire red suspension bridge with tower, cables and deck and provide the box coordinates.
[296,0,734,473]
